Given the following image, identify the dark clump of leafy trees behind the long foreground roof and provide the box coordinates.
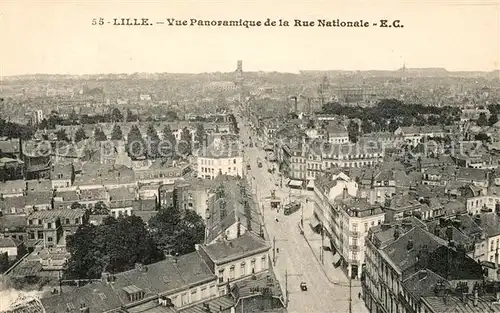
[64,207,205,279]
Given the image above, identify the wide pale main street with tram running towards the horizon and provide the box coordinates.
[239,114,367,313]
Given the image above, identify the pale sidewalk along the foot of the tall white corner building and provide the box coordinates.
[298,218,361,286]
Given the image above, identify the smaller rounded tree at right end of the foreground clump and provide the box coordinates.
[148,206,205,254]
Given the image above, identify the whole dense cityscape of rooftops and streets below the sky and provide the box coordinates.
[0,60,500,313]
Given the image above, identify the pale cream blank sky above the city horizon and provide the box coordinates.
[0,0,500,76]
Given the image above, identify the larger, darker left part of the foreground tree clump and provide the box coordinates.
[65,216,164,279]
